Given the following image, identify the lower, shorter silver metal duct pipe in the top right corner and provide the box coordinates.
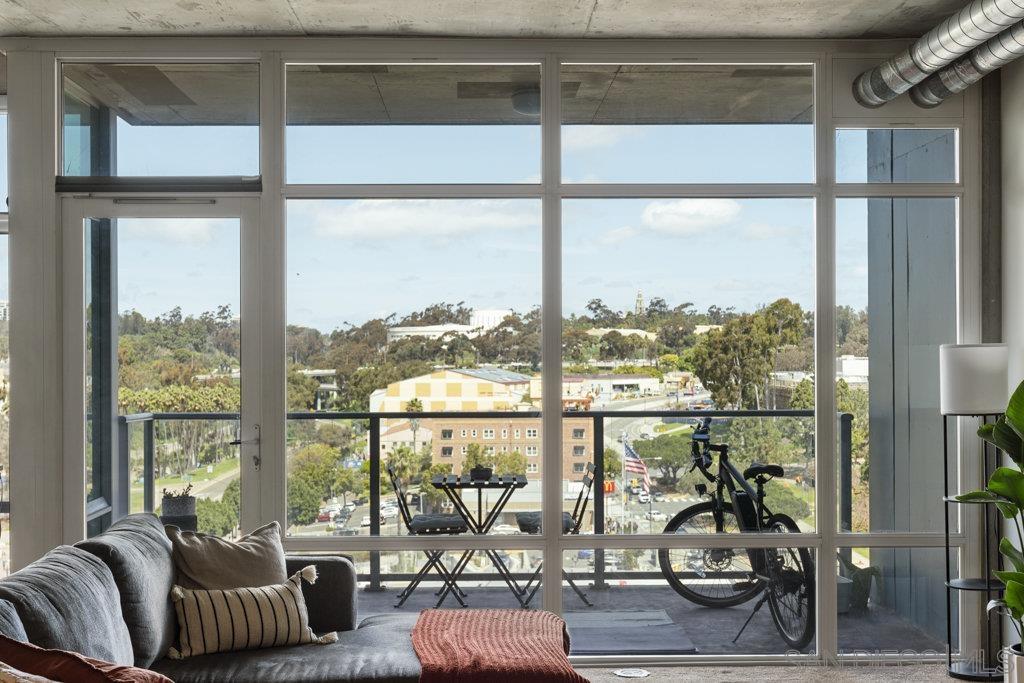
[910,22,1024,108]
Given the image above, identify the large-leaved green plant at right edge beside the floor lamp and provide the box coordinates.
[956,382,1024,683]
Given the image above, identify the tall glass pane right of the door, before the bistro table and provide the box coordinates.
[287,200,541,535]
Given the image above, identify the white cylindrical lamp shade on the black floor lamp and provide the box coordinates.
[939,344,1010,415]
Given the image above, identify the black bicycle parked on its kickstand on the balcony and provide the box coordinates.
[658,418,814,649]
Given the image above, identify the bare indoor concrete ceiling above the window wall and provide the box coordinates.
[0,0,966,38]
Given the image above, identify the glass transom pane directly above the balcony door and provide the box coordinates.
[61,63,259,176]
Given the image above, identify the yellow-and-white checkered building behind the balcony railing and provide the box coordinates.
[370,368,530,413]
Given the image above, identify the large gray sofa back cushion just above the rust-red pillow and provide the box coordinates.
[0,546,134,665]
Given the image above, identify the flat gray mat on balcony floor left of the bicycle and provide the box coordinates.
[564,609,697,654]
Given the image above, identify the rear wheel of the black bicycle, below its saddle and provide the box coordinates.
[765,514,815,650]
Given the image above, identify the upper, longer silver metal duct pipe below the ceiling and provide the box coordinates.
[853,0,1024,106]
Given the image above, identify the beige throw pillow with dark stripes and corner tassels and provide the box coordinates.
[167,564,338,659]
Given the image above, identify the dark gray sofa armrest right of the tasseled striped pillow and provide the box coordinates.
[285,555,356,633]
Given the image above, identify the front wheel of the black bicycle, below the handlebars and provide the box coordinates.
[657,501,765,607]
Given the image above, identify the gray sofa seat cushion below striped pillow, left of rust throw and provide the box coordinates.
[153,613,420,683]
